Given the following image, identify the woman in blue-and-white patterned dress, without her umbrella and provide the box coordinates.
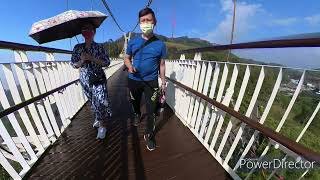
[71,23,112,139]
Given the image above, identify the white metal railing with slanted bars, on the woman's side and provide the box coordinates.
[0,44,123,179]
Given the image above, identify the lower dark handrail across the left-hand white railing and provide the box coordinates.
[0,79,79,118]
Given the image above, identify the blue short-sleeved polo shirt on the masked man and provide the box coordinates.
[126,36,167,81]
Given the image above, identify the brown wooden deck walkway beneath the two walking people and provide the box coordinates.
[26,70,231,180]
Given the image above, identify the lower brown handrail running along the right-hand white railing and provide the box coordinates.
[166,77,320,162]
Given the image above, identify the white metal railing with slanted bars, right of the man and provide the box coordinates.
[166,56,320,179]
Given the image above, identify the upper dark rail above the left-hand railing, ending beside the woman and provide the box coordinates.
[0,41,72,54]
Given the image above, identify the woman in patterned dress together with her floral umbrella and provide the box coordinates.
[29,10,111,139]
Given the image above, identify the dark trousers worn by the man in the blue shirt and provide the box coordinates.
[128,78,159,135]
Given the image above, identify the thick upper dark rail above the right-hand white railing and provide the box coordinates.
[175,36,320,54]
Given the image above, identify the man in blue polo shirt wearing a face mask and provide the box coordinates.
[124,8,167,151]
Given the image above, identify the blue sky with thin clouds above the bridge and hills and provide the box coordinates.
[0,0,320,68]
